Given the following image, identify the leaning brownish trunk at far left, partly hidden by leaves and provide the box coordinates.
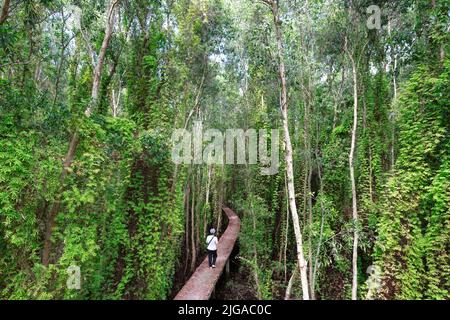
[42,0,119,266]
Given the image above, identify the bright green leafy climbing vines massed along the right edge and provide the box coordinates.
[375,60,450,299]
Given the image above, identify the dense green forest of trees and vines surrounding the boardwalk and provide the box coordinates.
[0,0,450,300]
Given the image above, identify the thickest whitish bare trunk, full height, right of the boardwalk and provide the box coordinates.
[269,1,309,300]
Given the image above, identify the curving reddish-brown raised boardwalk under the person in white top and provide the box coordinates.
[174,208,241,300]
